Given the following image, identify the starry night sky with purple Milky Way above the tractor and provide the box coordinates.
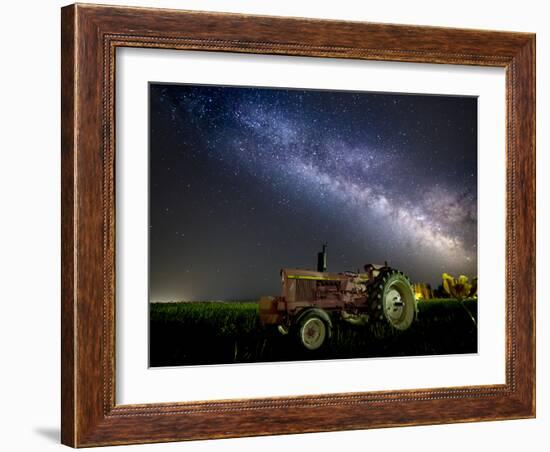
[149,83,477,301]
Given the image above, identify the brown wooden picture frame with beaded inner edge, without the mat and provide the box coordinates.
[61,4,535,447]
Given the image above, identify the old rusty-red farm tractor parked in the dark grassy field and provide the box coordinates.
[259,244,417,353]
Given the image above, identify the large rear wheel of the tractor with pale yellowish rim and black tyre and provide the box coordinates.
[371,269,416,330]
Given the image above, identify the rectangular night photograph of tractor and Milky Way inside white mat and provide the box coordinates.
[149,83,477,367]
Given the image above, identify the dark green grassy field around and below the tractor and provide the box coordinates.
[149,299,477,367]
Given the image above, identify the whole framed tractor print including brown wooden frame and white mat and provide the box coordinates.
[62,4,535,447]
